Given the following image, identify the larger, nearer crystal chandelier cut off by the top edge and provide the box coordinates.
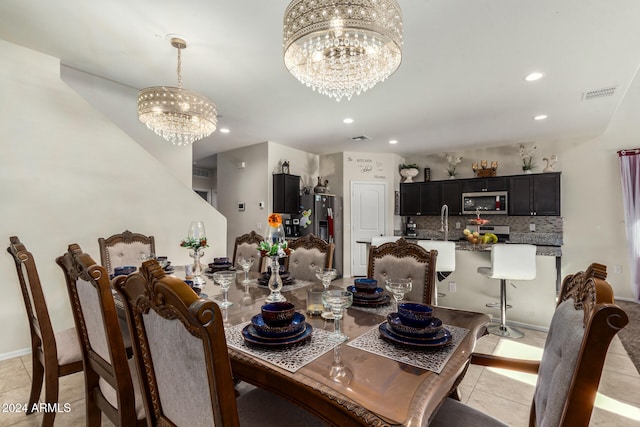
[283,0,402,101]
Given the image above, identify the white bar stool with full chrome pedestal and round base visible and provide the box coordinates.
[478,244,536,338]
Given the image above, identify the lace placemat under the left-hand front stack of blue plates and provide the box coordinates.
[225,322,341,372]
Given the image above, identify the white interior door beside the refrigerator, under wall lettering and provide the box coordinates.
[351,182,387,276]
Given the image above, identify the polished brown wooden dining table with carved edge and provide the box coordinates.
[203,271,490,426]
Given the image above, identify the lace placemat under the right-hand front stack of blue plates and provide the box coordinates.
[347,325,469,374]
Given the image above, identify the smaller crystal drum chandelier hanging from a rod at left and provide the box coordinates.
[138,38,218,145]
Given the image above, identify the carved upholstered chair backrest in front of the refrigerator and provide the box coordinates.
[285,234,336,282]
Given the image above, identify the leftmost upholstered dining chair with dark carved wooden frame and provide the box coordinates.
[7,236,82,427]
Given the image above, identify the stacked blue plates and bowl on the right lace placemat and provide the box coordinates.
[378,303,451,348]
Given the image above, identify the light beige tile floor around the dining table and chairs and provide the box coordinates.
[0,329,640,427]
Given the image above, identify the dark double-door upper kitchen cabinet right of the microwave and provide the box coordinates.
[509,172,560,216]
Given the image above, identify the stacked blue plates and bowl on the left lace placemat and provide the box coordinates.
[242,303,313,348]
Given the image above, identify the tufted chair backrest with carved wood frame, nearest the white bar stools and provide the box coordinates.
[367,238,437,304]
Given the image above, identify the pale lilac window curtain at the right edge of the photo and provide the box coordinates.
[618,148,640,302]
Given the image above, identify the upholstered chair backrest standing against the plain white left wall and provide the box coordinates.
[98,230,156,274]
